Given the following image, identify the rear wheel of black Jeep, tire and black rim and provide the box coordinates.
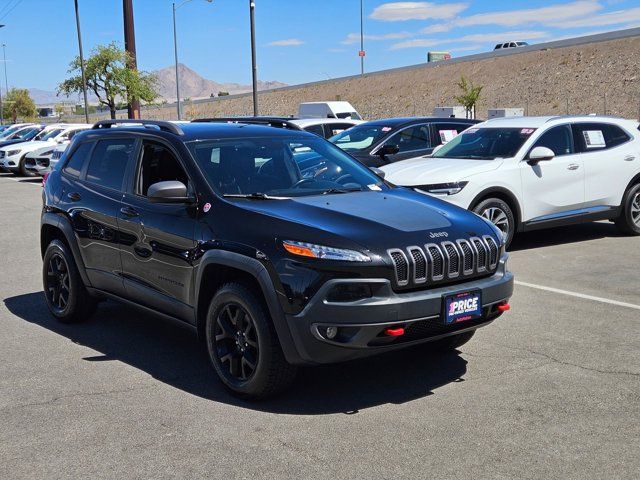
[42,240,98,323]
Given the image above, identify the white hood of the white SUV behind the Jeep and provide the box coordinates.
[381,157,503,186]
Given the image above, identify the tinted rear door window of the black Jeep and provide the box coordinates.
[86,138,135,190]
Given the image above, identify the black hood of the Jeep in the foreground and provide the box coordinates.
[232,188,495,253]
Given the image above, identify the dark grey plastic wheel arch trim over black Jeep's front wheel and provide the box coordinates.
[194,250,300,363]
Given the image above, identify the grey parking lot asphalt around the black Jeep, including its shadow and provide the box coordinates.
[0,174,640,479]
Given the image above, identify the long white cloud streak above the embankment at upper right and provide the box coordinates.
[421,0,602,34]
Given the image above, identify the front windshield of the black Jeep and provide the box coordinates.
[188,137,388,199]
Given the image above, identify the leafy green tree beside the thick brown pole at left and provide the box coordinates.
[58,42,158,119]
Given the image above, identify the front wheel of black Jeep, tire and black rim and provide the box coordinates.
[206,283,297,399]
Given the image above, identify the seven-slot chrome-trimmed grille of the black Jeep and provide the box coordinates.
[388,235,500,287]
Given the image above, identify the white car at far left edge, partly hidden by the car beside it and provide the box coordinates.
[0,124,91,176]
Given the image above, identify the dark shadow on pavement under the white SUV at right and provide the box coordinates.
[509,222,624,252]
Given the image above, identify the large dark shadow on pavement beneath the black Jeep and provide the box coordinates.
[4,292,467,415]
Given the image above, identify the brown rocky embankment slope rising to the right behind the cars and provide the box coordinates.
[145,37,640,119]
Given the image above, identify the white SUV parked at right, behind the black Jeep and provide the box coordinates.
[381,115,640,243]
